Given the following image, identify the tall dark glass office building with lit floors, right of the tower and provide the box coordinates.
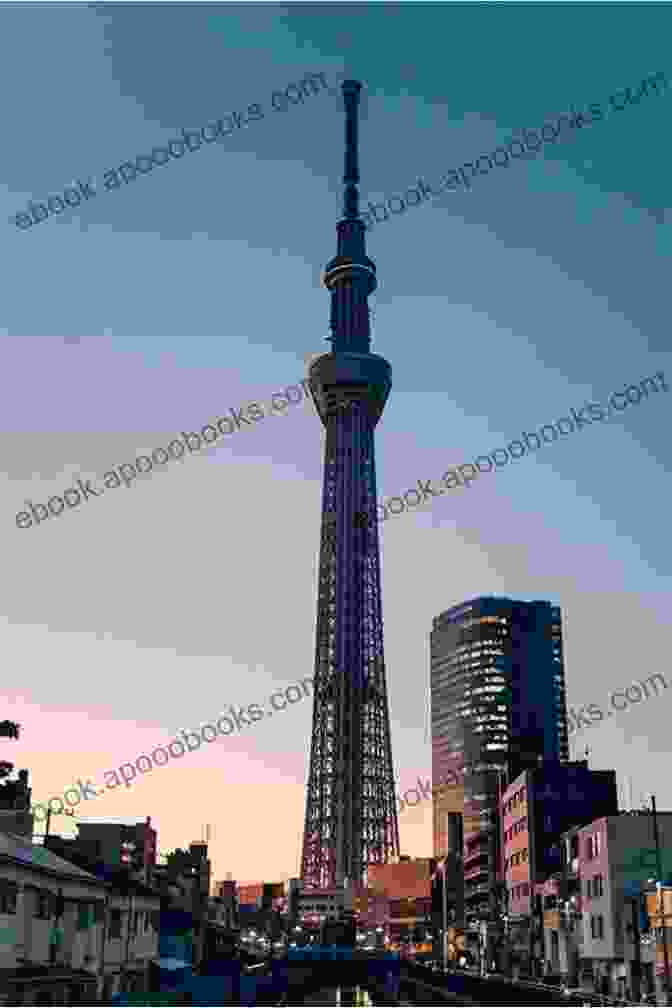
[431,597,569,922]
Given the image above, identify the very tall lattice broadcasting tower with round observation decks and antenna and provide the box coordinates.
[301,81,399,888]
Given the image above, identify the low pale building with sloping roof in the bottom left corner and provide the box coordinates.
[0,834,159,1005]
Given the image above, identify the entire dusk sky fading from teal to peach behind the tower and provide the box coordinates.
[0,4,672,878]
